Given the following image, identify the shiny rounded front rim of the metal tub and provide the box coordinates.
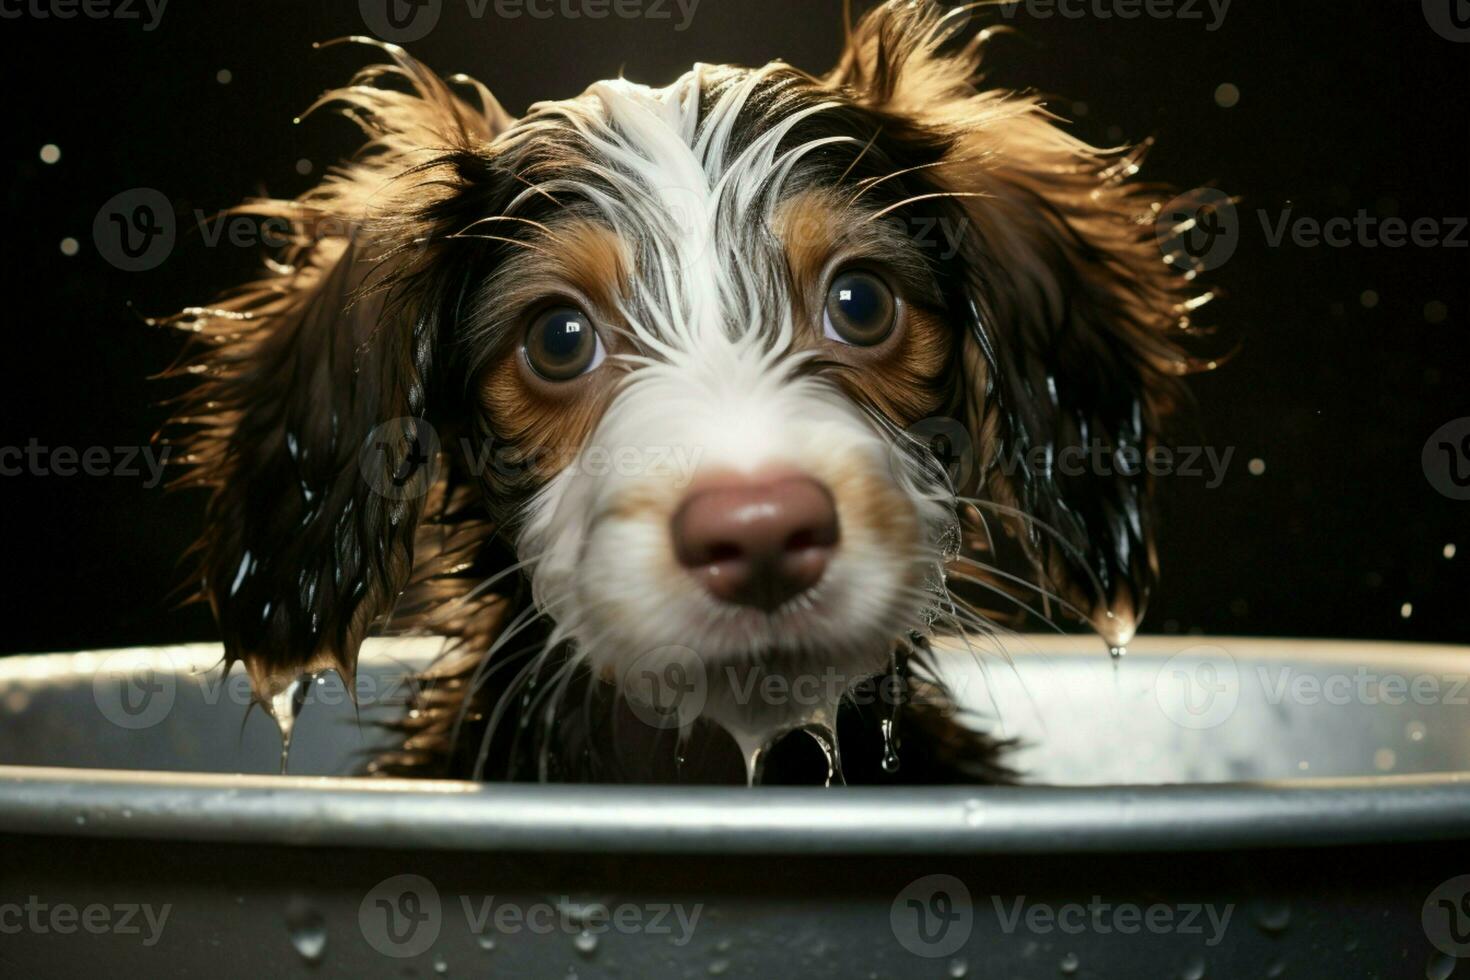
[0,765,1470,855]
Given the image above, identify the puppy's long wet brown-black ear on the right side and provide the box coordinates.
[826,0,1208,644]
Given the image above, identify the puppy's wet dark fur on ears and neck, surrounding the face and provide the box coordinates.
[169,3,1211,782]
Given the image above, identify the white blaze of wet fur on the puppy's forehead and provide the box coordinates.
[513,63,860,363]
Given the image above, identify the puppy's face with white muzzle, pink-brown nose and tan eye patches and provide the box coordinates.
[466,76,954,731]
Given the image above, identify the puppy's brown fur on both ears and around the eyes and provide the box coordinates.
[169,0,1195,776]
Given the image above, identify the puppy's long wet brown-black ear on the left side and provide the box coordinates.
[161,46,507,704]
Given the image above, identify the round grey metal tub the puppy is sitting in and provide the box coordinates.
[0,636,1470,980]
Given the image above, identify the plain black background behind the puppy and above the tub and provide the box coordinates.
[0,0,1470,652]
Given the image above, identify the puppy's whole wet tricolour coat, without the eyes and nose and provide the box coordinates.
[172,0,1207,780]
